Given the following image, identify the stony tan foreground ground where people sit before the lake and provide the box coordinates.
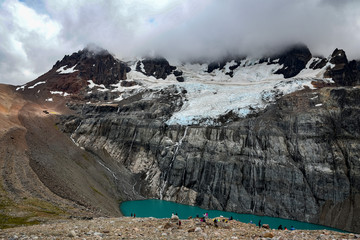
[0,217,360,239]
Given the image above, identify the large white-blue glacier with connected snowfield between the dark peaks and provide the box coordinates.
[112,58,331,125]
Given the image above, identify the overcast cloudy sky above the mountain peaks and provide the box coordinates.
[0,0,360,85]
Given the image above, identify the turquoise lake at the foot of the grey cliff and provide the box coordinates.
[120,199,343,232]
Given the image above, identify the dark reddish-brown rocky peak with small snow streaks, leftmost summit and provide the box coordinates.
[24,48,130,98]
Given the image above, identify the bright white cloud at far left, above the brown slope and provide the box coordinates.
[0,0,75,84]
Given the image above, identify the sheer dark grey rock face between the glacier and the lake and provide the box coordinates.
[63,88,360,232]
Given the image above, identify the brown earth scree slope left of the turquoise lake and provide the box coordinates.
[0,85,137,228]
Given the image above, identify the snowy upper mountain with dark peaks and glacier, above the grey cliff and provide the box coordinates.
[17,45,359,125]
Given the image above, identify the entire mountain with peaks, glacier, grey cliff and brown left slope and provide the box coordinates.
[0,43,360,232]
